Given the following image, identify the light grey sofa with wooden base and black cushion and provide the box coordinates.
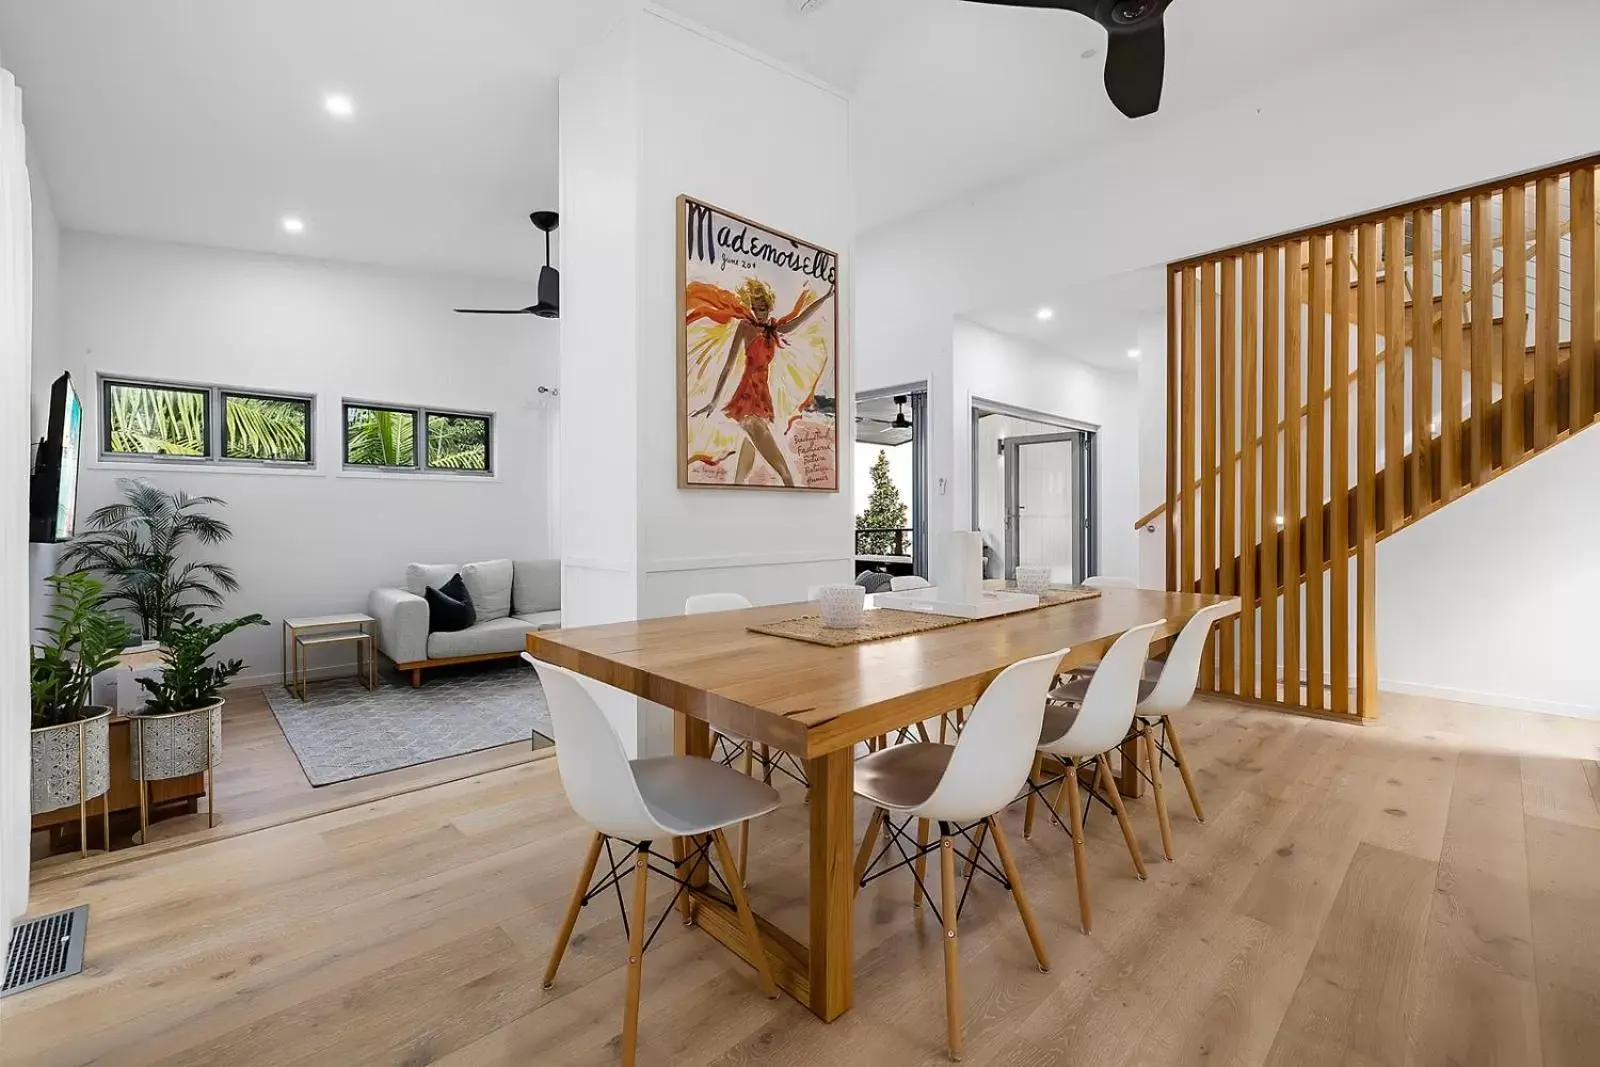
[366,560,562,685]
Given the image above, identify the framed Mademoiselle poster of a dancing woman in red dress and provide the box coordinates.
[678,197,838,493]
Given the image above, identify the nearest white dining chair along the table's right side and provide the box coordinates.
[856,649,1067,1059]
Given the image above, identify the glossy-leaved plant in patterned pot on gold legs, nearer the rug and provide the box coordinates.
[128,611,267,840]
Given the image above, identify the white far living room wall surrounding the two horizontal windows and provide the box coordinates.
[50,232,557,678]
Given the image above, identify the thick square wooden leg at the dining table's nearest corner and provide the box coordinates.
[806,749,856,1022]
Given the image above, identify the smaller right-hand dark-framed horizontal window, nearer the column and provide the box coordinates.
[344,400,494,474]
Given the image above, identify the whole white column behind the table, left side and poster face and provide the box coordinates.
[560,5,854,752]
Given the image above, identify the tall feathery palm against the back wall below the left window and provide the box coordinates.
[61,478,238,641]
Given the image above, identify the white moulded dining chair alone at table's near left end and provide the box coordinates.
[522,653,778,1067]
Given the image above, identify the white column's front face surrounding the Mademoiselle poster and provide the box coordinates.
[638,13,854,616]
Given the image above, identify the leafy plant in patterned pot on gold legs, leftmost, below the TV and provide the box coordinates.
[29,571,131,851]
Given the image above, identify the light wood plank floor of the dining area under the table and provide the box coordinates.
[0,696,1600,1067]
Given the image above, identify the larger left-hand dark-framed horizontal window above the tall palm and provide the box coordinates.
[101,378,315,467]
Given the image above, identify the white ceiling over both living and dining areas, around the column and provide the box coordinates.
[0,0,1445,277]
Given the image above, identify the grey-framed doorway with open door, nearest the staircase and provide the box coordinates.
[973,400,1099,585]
